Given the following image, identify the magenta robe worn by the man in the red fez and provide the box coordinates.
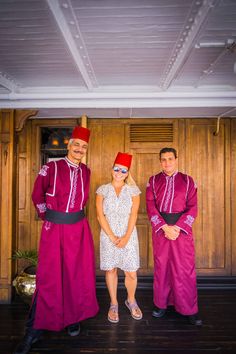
[32,158,98,331]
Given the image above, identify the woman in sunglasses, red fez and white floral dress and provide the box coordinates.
[96,152,142,323]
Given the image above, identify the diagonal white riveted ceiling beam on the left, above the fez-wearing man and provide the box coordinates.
[47,0,96,91]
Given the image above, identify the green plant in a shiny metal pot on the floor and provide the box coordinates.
[12,250,38,304]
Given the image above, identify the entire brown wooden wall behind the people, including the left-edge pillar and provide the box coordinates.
[0,117,236,302]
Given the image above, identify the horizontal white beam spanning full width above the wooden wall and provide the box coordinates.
[0,92,236,110]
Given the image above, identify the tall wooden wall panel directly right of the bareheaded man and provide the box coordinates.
[186,119,230,275]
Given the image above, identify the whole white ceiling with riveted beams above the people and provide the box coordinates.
[0,0,236,118]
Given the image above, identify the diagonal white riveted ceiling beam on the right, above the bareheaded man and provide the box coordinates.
[161,0,218,90]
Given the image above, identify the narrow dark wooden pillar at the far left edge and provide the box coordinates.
[0,109,15,303]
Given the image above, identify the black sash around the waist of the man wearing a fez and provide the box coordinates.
[45,209,85,224]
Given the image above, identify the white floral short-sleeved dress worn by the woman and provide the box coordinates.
[96,183,141,272]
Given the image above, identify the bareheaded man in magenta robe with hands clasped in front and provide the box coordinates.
[146,148,202,326]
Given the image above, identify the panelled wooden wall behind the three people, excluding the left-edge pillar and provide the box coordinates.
[13,119,236,275]
